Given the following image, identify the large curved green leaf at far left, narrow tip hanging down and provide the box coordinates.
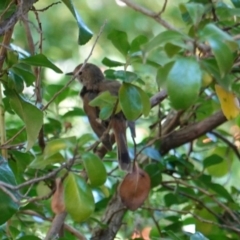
[5,90,43,151]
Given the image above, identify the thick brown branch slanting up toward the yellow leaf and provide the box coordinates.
[160,111,227,155]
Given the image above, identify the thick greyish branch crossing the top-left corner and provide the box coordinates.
[0,0,37,36]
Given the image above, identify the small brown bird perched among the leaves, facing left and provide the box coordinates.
[67,63,131,170]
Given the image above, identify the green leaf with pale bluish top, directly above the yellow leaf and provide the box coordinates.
[208,38,234,77]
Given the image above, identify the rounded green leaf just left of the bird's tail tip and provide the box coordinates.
[82,152,107,187]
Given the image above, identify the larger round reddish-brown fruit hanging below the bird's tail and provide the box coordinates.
[119,164,151,211]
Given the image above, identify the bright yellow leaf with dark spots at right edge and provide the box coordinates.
[215,85,240,120]
